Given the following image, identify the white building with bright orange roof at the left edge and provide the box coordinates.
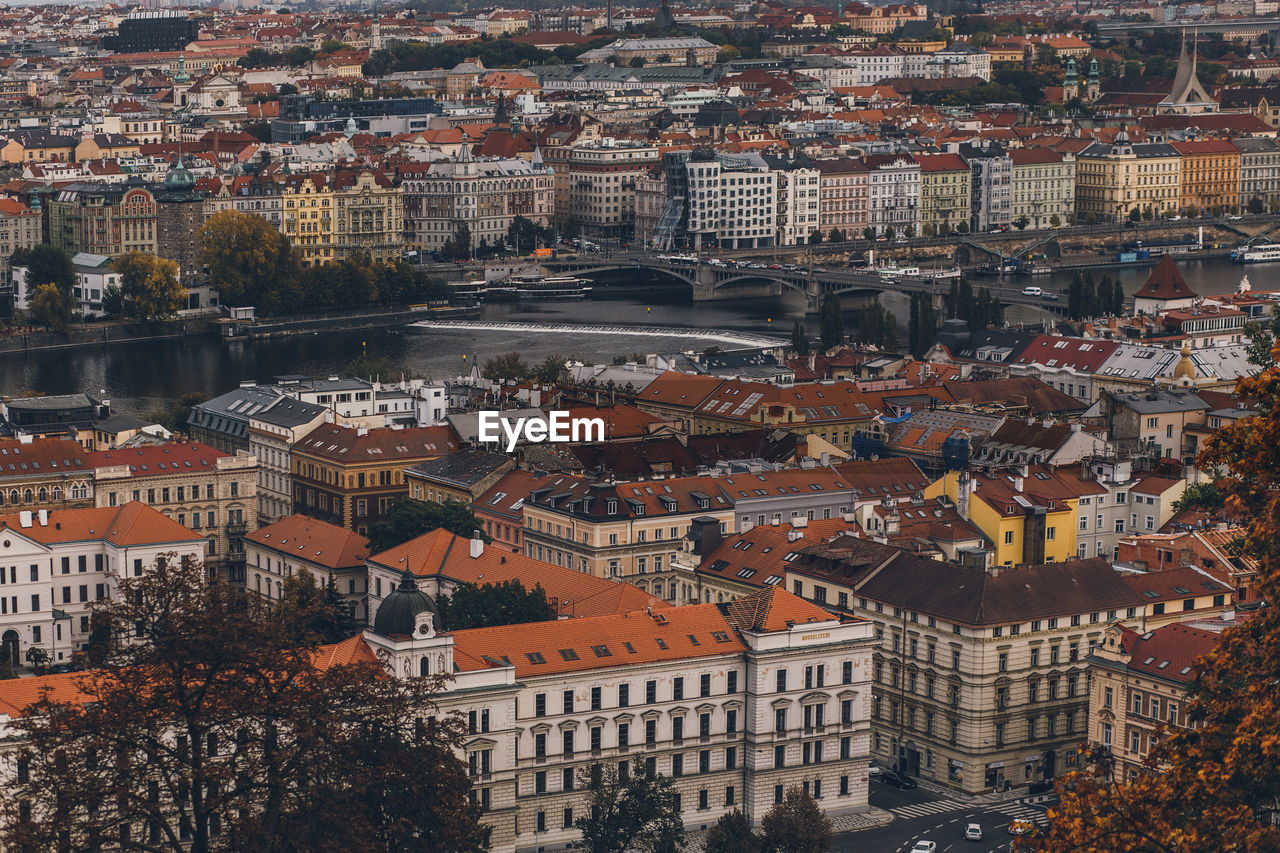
[0,501,205,666]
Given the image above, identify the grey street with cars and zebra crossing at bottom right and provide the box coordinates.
[831,783,1055,853]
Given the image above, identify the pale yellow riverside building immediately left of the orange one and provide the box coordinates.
[1075,132,1183,222]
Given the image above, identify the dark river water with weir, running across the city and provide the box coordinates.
[0,252,1280,415]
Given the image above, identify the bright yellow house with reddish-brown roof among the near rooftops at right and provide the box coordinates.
[924,465,1079,566]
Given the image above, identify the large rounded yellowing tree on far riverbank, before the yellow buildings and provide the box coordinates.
[200,210,296,305]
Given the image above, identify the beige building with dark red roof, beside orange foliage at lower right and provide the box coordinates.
[1088,614,1219,781]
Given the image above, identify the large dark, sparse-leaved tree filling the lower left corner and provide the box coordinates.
[0,555,488,853]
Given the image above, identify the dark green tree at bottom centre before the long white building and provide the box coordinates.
[573,756,685,853]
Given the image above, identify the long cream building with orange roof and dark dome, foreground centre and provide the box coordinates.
[365,578,874,853]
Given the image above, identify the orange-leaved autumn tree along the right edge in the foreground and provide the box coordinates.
[1019,348,1280,853]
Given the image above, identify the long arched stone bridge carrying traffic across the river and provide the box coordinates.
[541,252,1065,311]
